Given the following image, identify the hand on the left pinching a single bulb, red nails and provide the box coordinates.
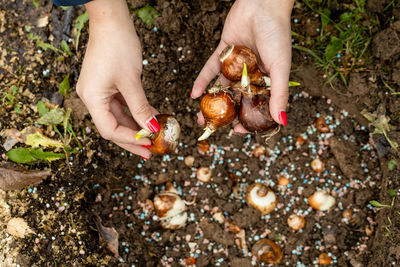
[76,0,160,159]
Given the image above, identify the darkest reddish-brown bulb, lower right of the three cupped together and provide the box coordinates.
[239,89,278,133]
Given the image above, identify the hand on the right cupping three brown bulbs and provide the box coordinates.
[191,0,294,133]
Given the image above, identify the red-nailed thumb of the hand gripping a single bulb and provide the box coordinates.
[119,79,161,133]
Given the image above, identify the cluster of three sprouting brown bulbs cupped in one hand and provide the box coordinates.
[199,45,278,140]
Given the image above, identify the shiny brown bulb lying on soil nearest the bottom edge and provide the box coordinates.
[251,239,283,264]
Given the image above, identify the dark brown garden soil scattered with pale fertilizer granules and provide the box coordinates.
[0,0,400,267]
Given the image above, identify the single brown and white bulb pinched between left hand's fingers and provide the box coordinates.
[149,114,181,155]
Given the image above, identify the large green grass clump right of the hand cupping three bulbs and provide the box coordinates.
[292,0,374,86]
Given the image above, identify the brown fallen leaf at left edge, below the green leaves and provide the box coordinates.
[0,163,51,190]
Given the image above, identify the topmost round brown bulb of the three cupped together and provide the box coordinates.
[219,44,260,81]
